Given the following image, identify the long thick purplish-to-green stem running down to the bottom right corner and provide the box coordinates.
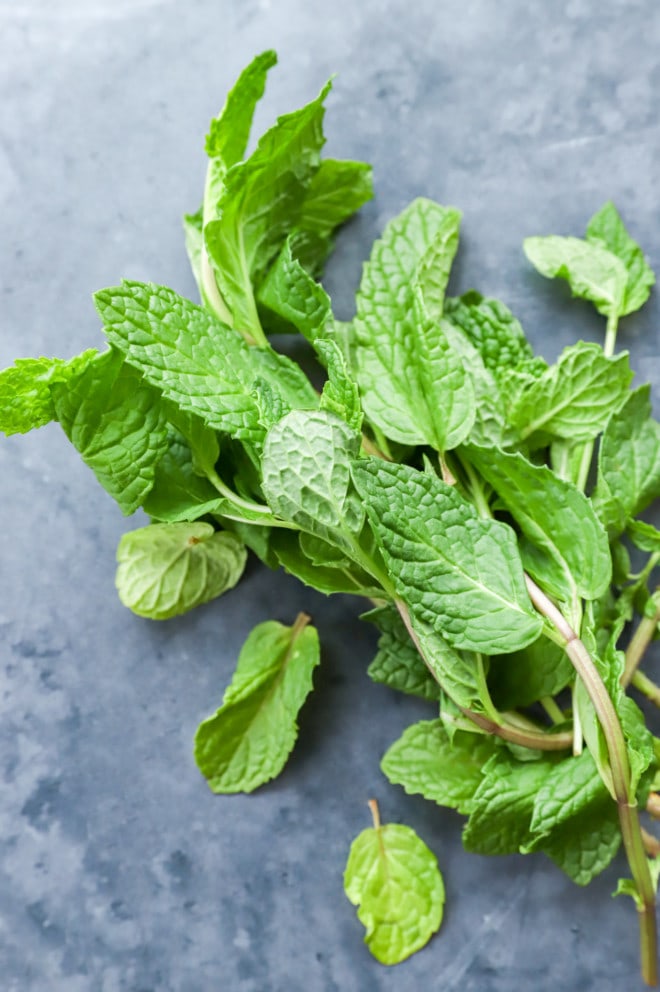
[525,575,658,985]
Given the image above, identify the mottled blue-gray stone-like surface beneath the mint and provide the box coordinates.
[0,0,660,992]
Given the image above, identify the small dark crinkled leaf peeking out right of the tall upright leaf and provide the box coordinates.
[444,291,533,378]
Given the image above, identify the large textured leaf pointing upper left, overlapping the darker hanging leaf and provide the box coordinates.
[95,282,317,442]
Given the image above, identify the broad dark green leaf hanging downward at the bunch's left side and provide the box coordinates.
[51,350,168,514]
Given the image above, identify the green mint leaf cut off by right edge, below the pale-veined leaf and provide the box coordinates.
[594,386,660,537]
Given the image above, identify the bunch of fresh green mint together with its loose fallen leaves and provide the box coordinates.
[0,52,660,984]
